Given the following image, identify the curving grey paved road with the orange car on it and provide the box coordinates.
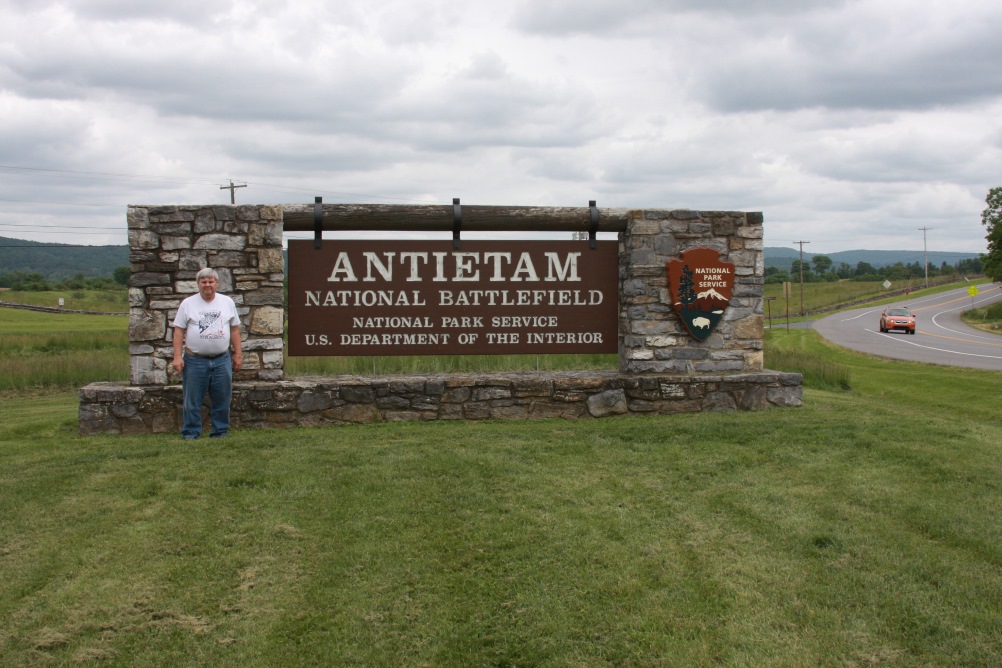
[814,283,1002,371]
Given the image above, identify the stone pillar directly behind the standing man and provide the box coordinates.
[128,205,285,386]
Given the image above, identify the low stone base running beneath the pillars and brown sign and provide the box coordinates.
[79,371,803,436]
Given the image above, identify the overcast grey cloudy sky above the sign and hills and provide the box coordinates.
[0,0,1002,252]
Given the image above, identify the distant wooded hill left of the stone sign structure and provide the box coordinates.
[0,236,128,280]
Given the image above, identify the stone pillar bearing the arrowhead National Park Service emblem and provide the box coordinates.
[619,209,765,375]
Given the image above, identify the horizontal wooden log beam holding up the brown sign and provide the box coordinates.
[282,204,629,232]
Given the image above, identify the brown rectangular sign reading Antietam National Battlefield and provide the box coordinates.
[289,239,619,356]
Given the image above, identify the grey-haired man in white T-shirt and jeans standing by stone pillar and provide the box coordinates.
[173,267,243,439]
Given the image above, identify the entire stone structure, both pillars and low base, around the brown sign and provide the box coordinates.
[79,206,802,434]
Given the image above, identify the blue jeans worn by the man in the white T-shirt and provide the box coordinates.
[181,352,233,439]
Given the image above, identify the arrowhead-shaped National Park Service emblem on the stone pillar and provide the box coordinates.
[667,248,734,341]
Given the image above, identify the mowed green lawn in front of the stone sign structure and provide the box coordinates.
[0,320,1002,666]
